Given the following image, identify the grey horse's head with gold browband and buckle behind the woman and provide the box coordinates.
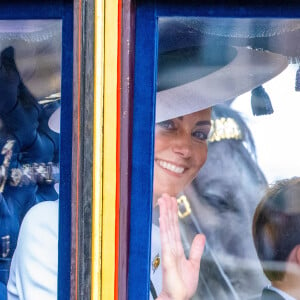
[178,105,267,300]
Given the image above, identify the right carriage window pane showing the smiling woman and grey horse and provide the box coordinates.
[150,17,300,299]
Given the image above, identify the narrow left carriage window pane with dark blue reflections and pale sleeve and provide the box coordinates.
[0,20,61,299]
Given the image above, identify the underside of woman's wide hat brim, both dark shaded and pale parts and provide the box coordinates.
[156,45,288,122]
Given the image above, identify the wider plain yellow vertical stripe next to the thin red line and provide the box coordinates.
[101,0,118,300]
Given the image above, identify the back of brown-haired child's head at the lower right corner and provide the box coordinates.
[253,177,300,300]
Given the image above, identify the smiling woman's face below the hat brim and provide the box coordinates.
[153,108,211,201]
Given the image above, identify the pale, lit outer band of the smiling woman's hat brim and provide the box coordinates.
[156,47,288,123]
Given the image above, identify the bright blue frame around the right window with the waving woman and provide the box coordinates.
[127,0,300,299]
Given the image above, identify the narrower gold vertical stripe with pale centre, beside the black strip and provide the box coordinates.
[91,0,104,300]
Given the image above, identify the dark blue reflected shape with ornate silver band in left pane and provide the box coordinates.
[0,47,60,299]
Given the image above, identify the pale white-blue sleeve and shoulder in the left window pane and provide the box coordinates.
[7,200,58,300]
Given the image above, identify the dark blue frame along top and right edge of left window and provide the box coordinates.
[0,0,73,300]
